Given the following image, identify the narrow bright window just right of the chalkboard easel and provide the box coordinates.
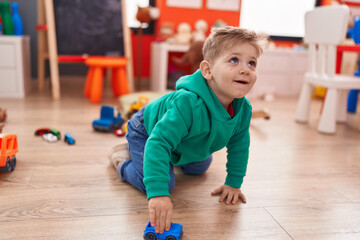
[126,0,155,34]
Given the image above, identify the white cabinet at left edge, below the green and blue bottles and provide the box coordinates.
[0,36,31,98]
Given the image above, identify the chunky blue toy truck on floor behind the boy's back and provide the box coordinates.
[92,105,124,132]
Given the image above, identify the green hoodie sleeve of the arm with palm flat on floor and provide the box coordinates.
[225,108,252,188]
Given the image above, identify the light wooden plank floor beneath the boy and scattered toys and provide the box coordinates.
[0,79,360,240]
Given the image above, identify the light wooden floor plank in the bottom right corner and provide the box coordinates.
[266,203,360,239]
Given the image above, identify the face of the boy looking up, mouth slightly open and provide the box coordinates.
[205,43,258,105]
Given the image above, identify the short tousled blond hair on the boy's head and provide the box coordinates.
[202,26,267,62]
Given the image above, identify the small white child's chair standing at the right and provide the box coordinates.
[295,5,360,134]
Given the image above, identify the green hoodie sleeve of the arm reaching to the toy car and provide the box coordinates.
[143,94,192,199]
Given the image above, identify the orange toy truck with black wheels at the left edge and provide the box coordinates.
[0,134,18,173]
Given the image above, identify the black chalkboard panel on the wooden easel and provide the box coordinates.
[54,0,125,56]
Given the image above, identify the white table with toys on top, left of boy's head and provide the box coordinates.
[150,42,190,92]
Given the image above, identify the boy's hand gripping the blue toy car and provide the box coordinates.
[149,196,173,233]
